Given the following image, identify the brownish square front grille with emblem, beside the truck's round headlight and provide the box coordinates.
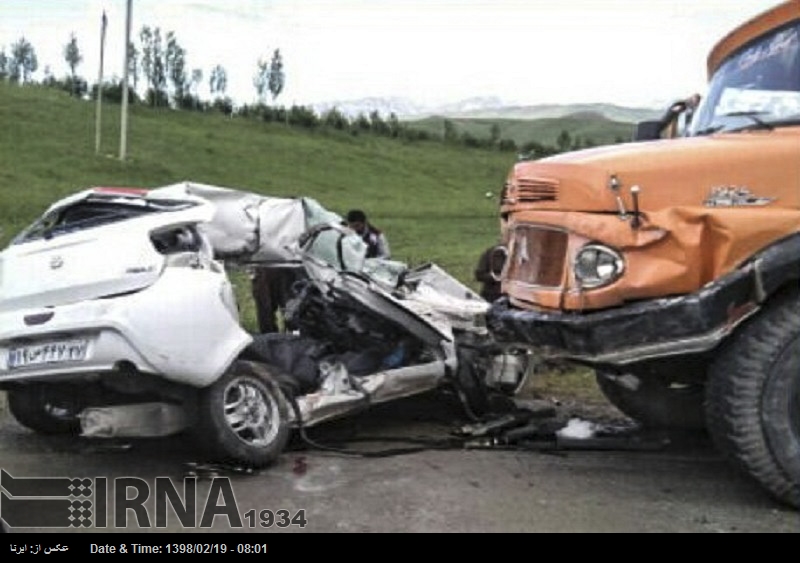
[507,225,568,288]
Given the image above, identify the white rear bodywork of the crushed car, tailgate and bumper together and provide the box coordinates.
[0,190,252,387]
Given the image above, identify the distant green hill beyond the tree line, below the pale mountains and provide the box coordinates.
[406,112,634,146]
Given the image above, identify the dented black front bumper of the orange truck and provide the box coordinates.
[487,263,765,366]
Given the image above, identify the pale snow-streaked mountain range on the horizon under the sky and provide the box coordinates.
[313,97,666,123]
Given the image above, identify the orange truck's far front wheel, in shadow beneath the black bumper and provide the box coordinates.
[596,371,706,430]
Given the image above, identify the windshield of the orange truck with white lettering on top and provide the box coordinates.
[689,22,800,135]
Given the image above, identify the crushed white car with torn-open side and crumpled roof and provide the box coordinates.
[0,183,530,467]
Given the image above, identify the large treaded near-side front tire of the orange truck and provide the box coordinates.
[706,289,800,508]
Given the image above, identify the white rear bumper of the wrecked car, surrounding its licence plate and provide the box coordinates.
[0,268,252,387]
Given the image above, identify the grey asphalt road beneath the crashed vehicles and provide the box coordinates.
[0,396,800,533]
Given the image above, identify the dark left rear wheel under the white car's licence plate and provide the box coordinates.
[8,385,82,434]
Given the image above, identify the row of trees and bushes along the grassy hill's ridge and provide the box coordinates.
[0,32,624,159]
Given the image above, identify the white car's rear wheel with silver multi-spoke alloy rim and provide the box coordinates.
[198,361,289,467]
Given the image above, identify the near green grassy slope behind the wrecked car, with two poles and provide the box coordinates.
[0,84,514,290]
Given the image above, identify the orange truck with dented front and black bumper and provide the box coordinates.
[489,0,800,507]
